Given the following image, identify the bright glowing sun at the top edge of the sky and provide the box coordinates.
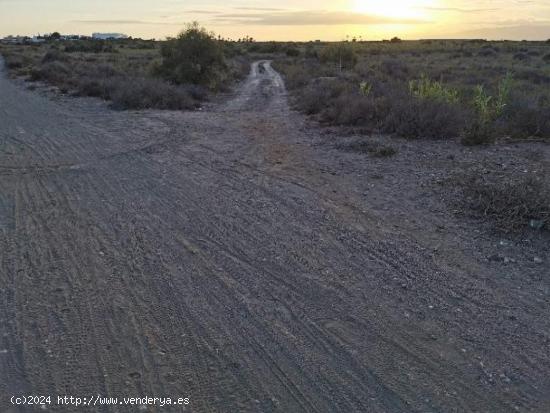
[352,0,432,19]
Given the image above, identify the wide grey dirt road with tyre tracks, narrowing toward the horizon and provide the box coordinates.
[0,62,550,413]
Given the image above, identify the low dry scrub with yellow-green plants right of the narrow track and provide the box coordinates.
[276,40,550,145]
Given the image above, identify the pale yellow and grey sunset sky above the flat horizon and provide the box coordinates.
[0,0,550,41]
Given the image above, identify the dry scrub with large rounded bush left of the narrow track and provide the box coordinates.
[0,23,249,109]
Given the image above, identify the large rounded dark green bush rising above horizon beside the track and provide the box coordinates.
[159,22,227,89]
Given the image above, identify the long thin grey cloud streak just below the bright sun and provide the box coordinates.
[215,10,427,26]
